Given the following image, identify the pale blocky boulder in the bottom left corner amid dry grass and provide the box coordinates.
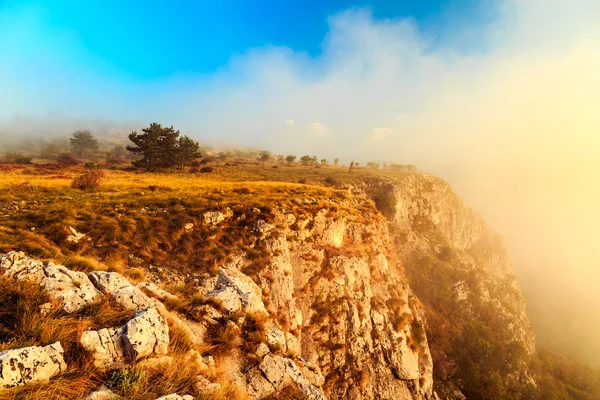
[0,342,67,388]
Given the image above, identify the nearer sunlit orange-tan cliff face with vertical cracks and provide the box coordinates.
[236,199,433,399]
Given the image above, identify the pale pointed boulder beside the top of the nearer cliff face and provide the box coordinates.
[207,268,266,313]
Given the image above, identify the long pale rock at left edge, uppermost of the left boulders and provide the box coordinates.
[0,251,101,313]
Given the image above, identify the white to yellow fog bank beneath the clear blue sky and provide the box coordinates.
[0,0,600,366]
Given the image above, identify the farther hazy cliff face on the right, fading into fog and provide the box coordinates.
[354,174,535,398]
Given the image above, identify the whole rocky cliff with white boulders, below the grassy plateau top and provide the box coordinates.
[0,173,534,400]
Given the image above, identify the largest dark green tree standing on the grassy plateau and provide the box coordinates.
[127,122,179,171]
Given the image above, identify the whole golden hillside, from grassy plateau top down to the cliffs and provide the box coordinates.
[0,168,600,400]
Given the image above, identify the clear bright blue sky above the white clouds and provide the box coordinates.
[0,0,493,81]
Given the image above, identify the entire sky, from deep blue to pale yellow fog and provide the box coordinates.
[0,0,600,365]
